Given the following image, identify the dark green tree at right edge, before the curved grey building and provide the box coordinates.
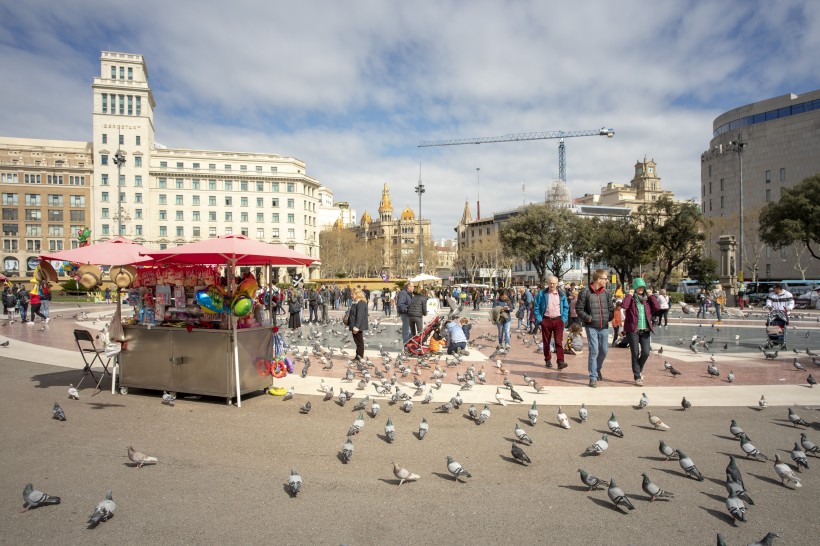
[760,174,820,260]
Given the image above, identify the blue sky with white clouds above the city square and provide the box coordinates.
[0,0,820,239]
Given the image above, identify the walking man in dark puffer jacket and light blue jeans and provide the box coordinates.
[575,269,615,388]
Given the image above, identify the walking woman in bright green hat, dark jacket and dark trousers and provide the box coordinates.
[621,277,660,386]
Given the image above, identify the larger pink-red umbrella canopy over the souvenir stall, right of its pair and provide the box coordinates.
[142,235,316,266]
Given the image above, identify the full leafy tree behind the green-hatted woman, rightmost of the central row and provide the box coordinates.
[633,197,707,287]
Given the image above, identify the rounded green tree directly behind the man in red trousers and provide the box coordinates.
[499,204,583,284]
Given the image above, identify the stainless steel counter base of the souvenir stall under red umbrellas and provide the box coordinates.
[119,325,273,404]
